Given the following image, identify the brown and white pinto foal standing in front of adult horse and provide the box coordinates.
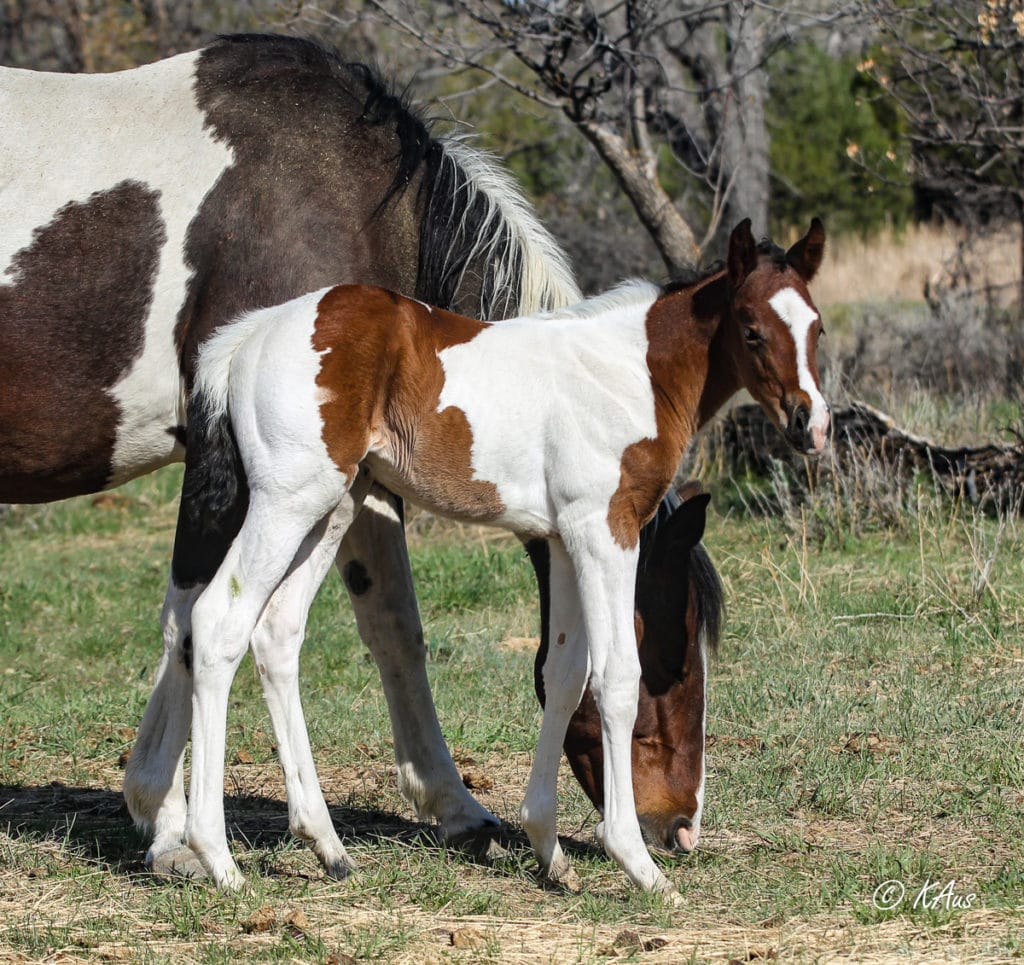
[185,219,828,892]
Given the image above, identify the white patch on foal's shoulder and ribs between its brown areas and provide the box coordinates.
[438,283,657,535]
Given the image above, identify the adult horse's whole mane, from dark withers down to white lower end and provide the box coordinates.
[207,34,580,319]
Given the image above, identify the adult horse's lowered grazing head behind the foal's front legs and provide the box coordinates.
[527,483,722,852]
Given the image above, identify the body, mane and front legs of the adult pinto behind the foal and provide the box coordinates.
[0,36,579,873]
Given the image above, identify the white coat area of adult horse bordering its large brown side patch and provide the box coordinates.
[0,53,233,486]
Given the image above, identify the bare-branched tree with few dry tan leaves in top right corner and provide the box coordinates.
[862,0,1024,306]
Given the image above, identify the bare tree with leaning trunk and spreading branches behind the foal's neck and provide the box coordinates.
[318,0,842,272]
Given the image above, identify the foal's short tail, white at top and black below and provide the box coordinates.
[181,316,255,538]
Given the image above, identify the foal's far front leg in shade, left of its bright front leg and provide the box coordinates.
[519,540,589,889]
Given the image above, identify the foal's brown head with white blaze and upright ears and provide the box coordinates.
[723,218,828,454]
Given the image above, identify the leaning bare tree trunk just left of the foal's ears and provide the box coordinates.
[578,121,700,276]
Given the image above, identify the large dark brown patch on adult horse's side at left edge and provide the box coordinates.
[0,180,166,503]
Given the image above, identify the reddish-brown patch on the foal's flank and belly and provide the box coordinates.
[313,285,505,520]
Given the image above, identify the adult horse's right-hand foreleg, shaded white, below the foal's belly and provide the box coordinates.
[338,486,499,840]
